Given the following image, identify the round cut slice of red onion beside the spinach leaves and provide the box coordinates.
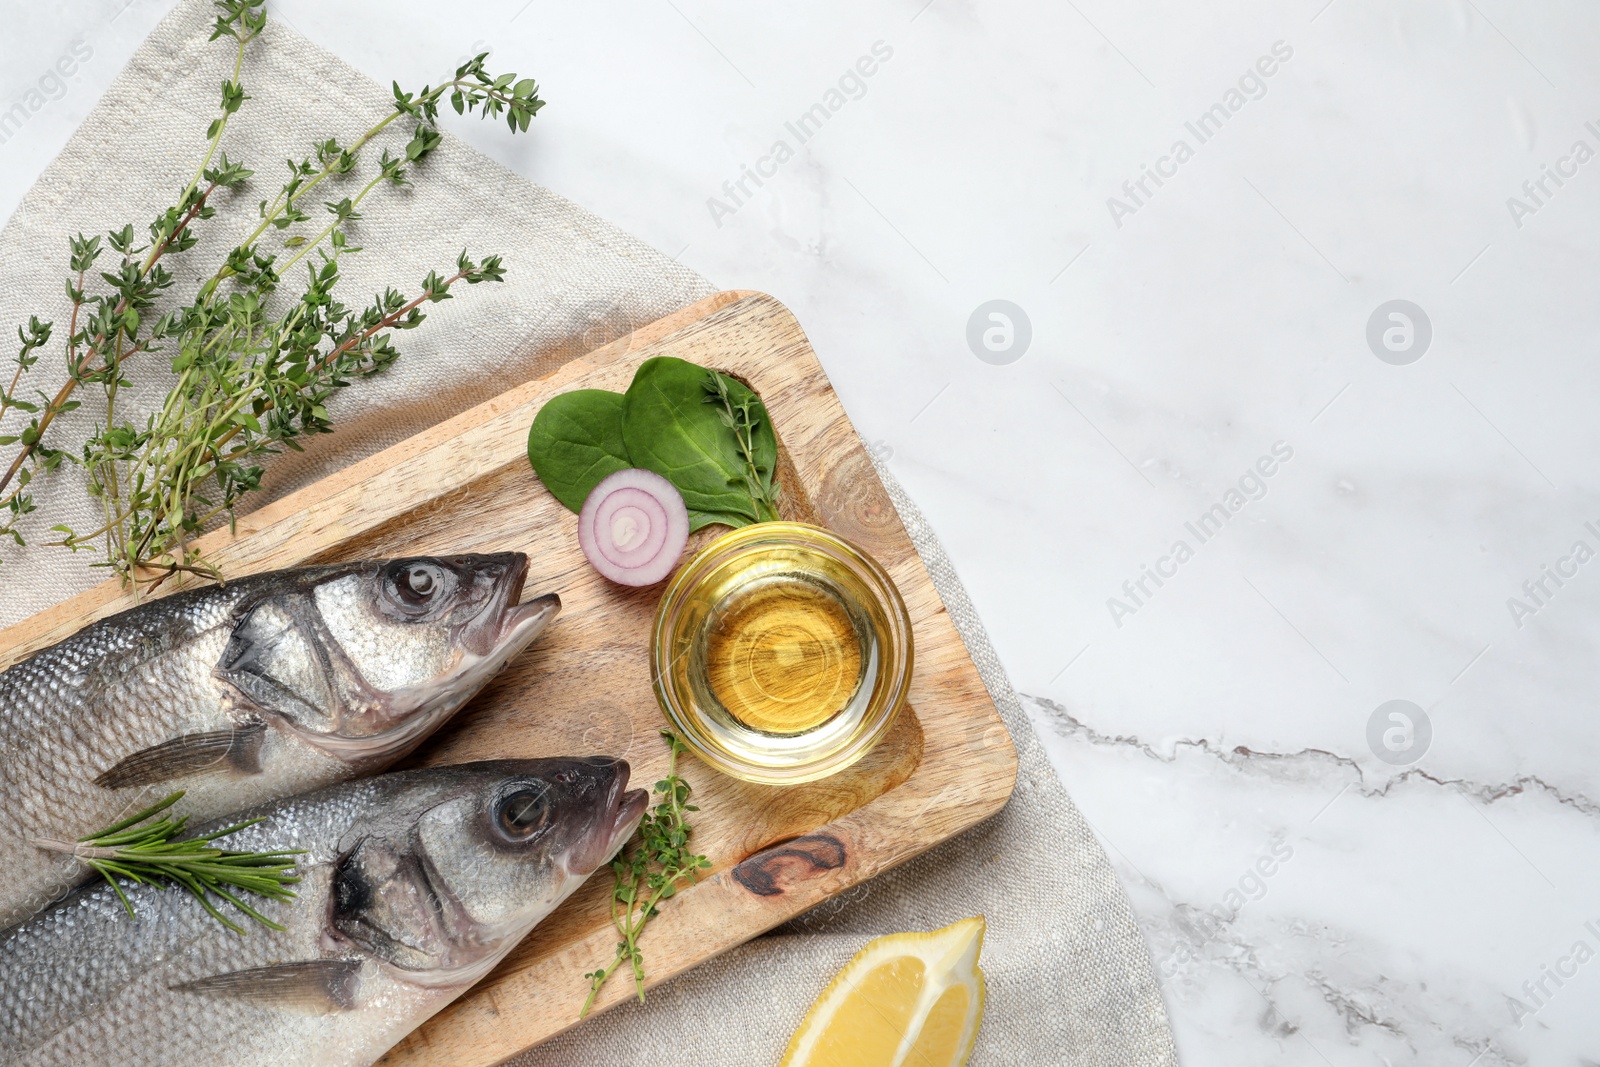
[578,467,690,585]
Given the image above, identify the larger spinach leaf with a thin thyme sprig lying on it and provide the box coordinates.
[622,355,778,530]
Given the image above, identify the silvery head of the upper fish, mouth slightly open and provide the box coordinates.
[218,552,562,769]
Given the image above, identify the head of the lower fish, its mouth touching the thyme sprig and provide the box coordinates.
[328,757,648,989]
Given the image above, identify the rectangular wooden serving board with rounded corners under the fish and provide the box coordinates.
[0,293,1016,1067]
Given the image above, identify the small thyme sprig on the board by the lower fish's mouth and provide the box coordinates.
[578,729,710,1019]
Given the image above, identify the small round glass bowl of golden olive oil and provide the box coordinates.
[651,523,912,784]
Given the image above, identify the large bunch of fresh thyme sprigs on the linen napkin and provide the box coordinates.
[0,0,544,582]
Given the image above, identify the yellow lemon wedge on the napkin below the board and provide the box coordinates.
[779,915,984,1067]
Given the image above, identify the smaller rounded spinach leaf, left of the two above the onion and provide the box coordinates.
[528,389,634,512]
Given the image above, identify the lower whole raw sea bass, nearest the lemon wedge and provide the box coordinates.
[0,757,648,1067]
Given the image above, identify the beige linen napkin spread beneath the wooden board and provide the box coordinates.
[0,0,1176,1067]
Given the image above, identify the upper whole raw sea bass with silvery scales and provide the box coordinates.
[0,552,560,928]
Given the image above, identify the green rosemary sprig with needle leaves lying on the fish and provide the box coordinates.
[34,792,304,934]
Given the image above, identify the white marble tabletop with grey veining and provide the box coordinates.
[0,0,1600,1067]
